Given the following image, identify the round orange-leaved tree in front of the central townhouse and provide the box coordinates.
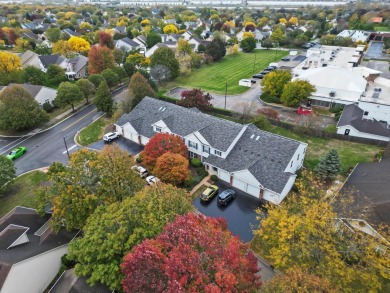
[154,153,190,185]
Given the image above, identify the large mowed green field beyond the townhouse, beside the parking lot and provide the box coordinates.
[175,50,288,95]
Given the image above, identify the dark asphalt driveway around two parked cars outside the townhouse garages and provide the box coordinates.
[193,180,261,242]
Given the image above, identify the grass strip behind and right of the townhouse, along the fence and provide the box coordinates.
[268,127,381,173]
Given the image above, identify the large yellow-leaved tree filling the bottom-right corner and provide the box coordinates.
[256,173,390,292]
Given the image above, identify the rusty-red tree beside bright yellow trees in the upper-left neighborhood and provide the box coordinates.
[88,45,115,74]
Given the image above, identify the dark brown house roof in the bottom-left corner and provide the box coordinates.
[0,207,77,289]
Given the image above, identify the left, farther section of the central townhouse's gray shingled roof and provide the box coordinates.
[116,97,242,151]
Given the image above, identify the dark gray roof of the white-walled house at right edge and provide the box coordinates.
[337,104,390,137]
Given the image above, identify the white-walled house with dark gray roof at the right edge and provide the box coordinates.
[337,104,390,141]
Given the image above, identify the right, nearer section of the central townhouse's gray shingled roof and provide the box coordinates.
[205,124,301,193]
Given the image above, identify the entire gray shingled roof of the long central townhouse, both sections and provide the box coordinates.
[116,97,301,193]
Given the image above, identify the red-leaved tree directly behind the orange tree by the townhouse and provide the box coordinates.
[142,133,188,170]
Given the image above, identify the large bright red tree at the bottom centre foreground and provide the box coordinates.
[121,213,261,293]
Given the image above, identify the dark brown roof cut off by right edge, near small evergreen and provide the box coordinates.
[342,158,390,225]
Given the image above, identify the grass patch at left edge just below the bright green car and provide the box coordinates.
[0,171,48,218]
